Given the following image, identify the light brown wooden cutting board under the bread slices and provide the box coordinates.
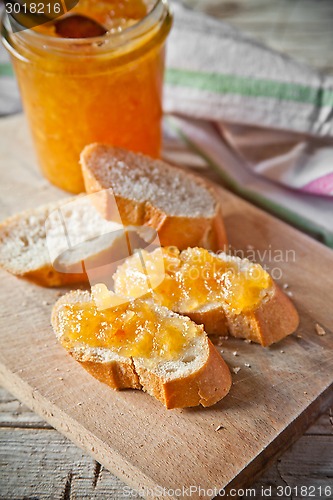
[0,117,333,498]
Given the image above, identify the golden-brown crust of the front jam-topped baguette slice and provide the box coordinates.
[51,290,232,409]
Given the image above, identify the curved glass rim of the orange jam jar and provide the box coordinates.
[0,0,171,52]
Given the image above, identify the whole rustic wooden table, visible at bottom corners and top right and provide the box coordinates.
[0,0,333,500]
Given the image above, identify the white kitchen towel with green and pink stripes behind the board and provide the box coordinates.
[164,2,333,247]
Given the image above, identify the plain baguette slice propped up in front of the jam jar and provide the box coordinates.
[81,144,227,251]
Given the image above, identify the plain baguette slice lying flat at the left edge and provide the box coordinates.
[0,196,128,287]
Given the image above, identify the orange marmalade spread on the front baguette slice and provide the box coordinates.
[59,299,202,360]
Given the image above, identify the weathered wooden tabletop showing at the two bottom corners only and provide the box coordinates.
[0,388,333,500]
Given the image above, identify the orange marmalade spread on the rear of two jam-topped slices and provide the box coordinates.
[114,247,273,314]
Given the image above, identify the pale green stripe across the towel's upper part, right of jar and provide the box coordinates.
[165,68,333,107]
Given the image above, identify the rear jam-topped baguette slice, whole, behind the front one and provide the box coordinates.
[114,248,299,346]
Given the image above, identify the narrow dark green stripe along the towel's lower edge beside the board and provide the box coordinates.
[169,120,333,248]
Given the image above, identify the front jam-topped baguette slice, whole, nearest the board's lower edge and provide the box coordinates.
[52,291,231,409]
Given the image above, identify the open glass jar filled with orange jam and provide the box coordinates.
[2,0,172,193]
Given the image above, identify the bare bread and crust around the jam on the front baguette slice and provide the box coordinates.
[51,291,231,409]
